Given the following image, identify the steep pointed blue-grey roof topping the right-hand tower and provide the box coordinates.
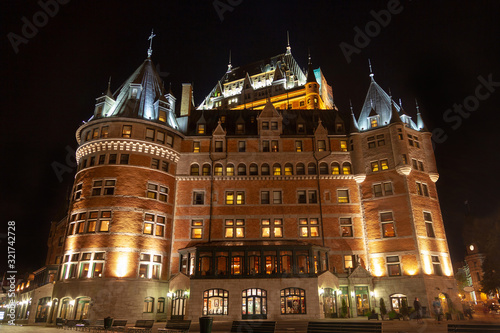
[358,74,400,131]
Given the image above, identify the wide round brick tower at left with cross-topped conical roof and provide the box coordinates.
[53,57,182,321]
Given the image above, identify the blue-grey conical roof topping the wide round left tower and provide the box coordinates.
[103,58,179,129]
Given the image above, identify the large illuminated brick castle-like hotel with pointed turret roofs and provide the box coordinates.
[16,40,457,323]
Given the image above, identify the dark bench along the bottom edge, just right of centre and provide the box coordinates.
[307,321,382,333]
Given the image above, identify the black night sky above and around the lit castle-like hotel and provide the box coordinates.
[0,0,500,271]
